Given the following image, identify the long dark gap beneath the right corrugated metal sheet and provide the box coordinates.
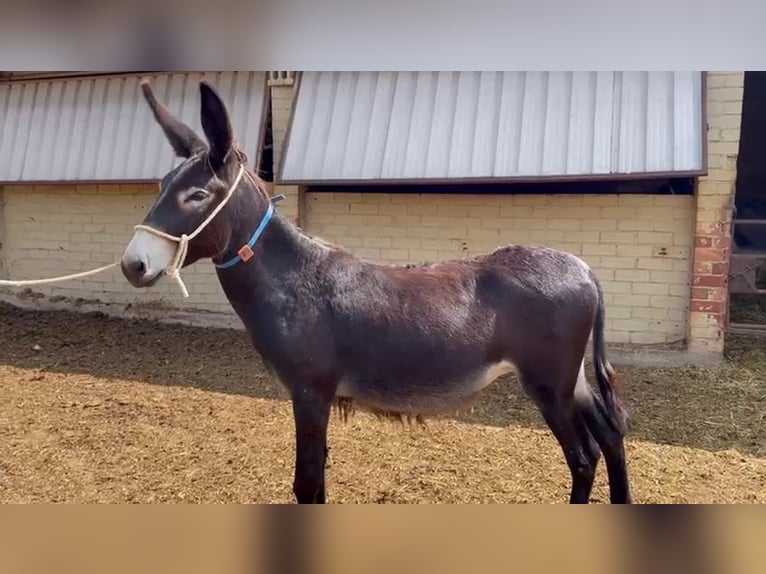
[310,177,696,195]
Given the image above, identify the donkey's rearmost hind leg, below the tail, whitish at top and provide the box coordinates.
[575,370,632,504]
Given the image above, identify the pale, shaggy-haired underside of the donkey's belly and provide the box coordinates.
[336,361,514,415]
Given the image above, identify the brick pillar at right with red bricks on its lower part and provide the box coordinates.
[688,72,744,355]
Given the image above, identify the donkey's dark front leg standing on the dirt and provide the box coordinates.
[293,387,334,504]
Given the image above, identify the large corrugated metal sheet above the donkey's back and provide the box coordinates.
[280,72,705,182]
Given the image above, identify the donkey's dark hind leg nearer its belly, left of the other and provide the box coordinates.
[520,367,599,504]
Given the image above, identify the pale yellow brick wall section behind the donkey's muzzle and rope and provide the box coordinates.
[3,185,230,312]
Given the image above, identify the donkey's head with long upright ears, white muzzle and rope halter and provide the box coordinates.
[122,82,260,287]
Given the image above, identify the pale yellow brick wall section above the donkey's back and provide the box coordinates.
[305,192,694,344]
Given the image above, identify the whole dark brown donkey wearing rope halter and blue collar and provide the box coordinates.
[122,82,631,503]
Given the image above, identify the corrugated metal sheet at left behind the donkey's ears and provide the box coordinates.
[0,72,267,182]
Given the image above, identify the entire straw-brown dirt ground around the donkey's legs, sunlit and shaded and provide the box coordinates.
[0,305,766,503]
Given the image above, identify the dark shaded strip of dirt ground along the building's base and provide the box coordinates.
[0,304,766,456]
